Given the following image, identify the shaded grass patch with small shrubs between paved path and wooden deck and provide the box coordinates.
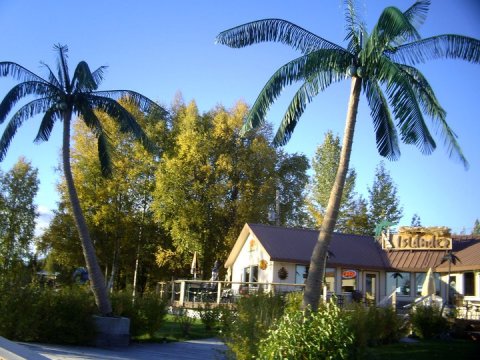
[135,315,218,342]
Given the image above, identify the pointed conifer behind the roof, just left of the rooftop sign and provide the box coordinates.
[368,161,403,226]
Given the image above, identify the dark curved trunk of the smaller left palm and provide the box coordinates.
[62,109,112,316]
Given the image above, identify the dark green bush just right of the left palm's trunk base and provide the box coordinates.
[112,290,167,338]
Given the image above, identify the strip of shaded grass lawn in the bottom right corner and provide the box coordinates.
[367,340,480,360]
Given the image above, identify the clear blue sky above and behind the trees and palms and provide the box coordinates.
[0,0,480,232]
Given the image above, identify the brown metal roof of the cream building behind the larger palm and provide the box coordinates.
[242,224,480,272]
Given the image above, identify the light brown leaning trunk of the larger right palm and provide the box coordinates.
[303,77,362,311]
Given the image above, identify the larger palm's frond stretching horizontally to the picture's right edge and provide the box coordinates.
[385,34,480,65]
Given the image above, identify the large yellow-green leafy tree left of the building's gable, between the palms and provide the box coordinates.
[154,102,276,276]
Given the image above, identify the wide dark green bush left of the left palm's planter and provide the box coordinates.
[0,285,95,344]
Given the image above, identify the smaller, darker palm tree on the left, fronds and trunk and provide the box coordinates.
[0,45,164,315]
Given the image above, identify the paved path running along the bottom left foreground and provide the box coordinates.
[15,339,227,360]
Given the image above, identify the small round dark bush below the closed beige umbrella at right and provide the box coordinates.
[410,305,448,339]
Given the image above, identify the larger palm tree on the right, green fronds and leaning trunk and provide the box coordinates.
[216,0,480,309]
